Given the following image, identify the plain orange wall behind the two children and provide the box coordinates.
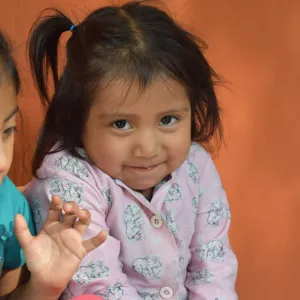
[0,0,300,300]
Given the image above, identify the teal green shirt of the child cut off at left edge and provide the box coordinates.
[0,177,35,275]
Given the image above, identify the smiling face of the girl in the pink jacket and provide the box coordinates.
[83,77,191,197]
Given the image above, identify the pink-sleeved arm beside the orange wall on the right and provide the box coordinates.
[186,157,237,300]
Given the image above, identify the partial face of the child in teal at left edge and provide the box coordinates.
[0,79,18,184]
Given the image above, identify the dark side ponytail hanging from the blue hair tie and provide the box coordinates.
[29,9,73,105]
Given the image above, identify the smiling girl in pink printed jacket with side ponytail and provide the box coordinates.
[26,2,237,300]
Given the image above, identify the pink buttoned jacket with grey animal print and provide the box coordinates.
[25,143,237,300]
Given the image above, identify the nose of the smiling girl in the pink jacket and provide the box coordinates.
[134,129,160,159]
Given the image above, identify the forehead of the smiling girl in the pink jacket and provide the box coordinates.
[94,76,189,114]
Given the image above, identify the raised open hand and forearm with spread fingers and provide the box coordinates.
[1,197,106,300]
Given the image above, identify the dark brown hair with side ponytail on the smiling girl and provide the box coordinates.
[29,1,222,176]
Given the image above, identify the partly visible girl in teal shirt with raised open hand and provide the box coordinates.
[0,34,105,300]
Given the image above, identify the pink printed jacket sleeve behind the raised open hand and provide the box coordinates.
[24,156,141,300]
